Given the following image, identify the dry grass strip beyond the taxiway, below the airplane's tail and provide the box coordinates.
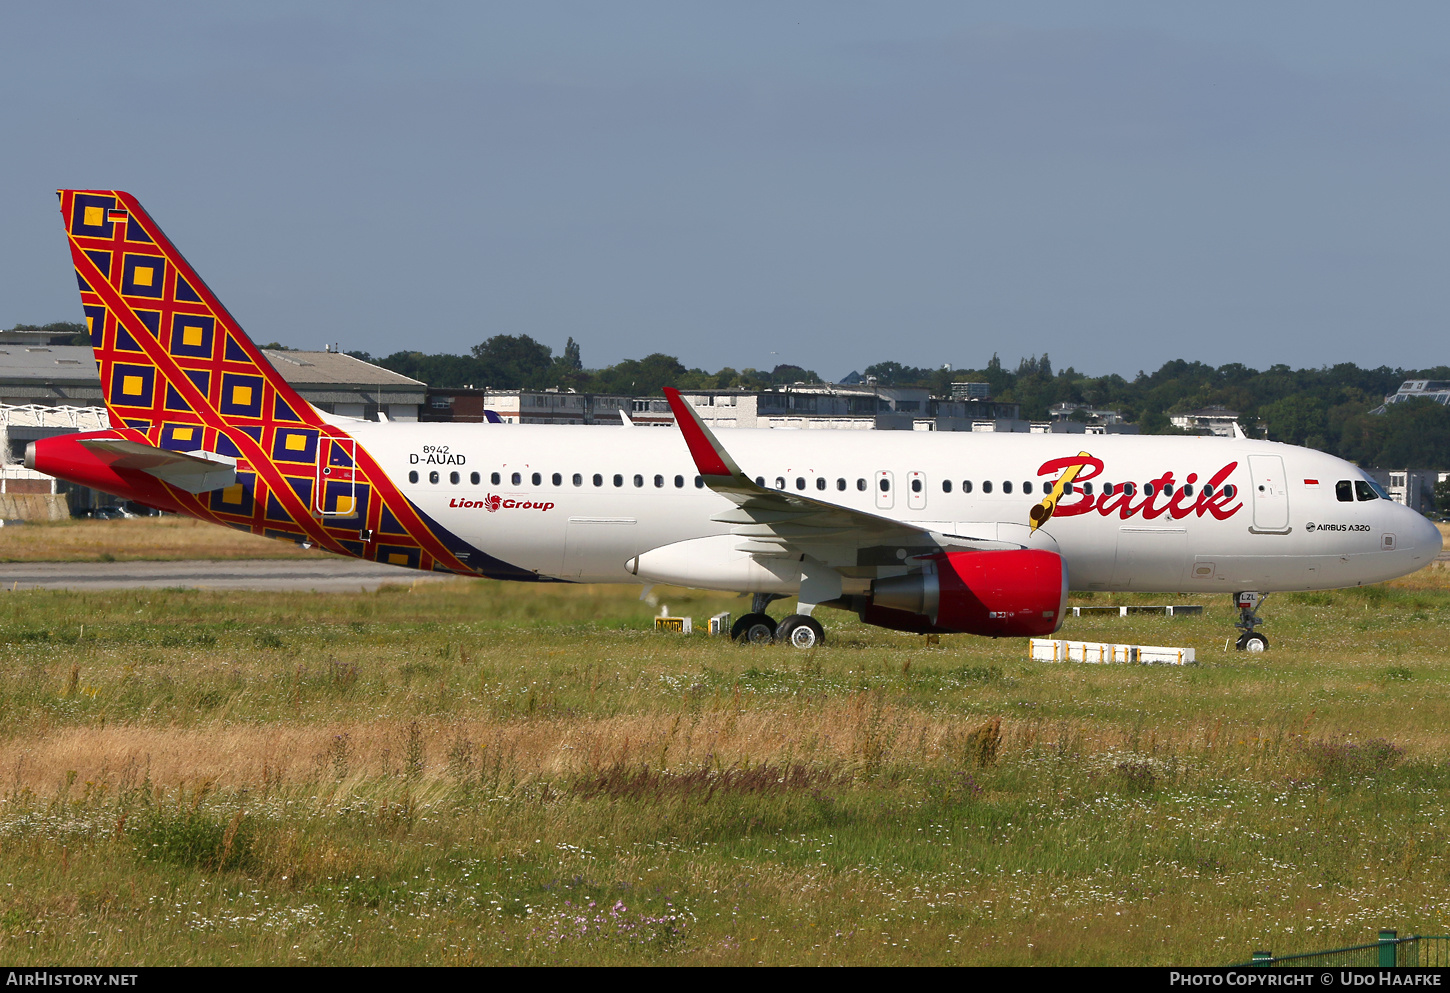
[0,516,322,562]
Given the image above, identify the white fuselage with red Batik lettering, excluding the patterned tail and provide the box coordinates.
[336,422,1441,593]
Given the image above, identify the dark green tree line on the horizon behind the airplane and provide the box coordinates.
[5,322,1450,468]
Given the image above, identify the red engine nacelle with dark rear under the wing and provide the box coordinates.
[860,548,1067,638]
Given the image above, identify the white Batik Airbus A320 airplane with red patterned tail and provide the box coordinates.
[26,190,1441,651]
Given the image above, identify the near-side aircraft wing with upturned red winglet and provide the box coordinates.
[664,387,974,556]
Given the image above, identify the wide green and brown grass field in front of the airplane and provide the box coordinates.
[0,568,1450,965]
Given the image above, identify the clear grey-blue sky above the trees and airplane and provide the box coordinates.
[0,0,1450,380]
